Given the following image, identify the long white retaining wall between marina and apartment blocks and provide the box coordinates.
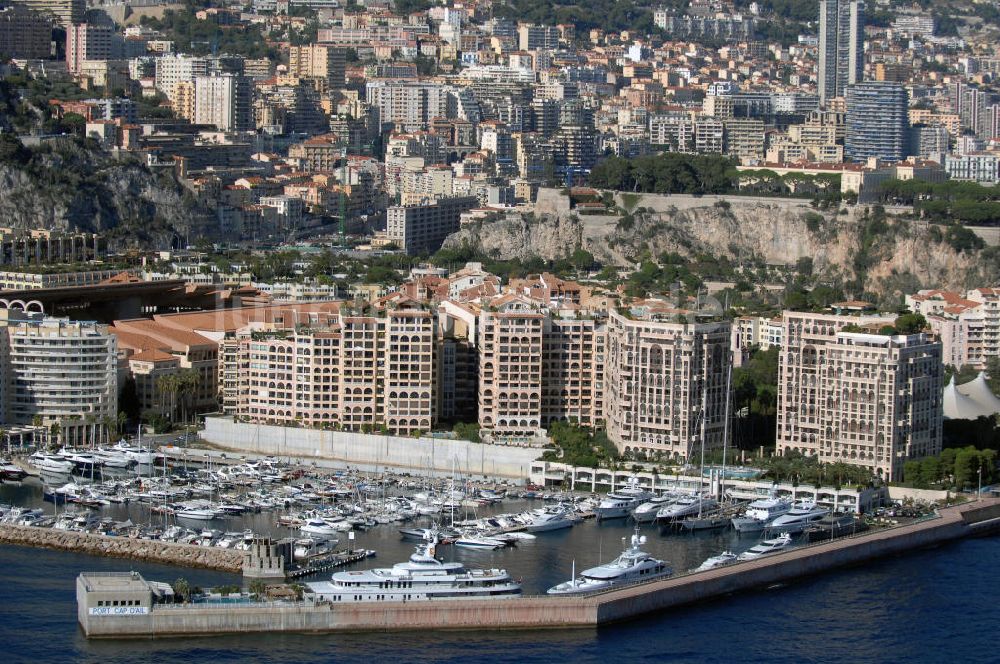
[201,416,542,479]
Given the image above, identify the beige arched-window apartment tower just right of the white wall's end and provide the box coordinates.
[604,308,730,459]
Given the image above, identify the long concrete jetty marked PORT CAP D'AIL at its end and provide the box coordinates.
[77,499,1000,638]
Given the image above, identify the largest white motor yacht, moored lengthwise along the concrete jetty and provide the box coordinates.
[306,539,521,604]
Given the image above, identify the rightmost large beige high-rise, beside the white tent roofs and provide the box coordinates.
[776,311,942,480]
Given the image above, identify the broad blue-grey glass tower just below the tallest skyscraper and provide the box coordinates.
[844,81,910,161]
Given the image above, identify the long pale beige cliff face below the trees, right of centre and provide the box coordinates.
[445,195,1000,292]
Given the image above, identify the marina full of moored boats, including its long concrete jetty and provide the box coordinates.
[0,448,1000,637]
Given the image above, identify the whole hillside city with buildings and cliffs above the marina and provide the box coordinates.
[0,0,1000,491]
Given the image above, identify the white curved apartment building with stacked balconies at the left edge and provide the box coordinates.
[0,310,118,445]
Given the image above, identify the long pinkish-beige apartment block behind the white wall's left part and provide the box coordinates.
[236,301,436,435]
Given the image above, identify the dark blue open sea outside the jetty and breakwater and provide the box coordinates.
[0,538,1000,664]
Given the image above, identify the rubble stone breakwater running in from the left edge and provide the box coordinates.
[0,524,243,573]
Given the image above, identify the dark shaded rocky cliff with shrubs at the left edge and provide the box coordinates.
[0,140,211,246]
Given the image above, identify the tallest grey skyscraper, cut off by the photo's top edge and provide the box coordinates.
[819,0,865,102]
